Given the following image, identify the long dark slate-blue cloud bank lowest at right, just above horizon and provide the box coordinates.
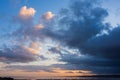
[58,54,120,74]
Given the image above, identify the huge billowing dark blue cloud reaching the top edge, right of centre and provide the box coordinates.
[47,0,108,47]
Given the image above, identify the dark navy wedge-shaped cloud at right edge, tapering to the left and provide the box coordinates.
[84,26,120,57]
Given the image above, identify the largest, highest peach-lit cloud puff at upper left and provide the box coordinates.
[19,6,36,19]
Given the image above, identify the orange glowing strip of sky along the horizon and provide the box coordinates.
[0,69,93,78]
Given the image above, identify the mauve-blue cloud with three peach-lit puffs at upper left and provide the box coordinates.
[12,6,54,41]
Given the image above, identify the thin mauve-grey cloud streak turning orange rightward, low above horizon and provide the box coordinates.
[4,65,92,76]
